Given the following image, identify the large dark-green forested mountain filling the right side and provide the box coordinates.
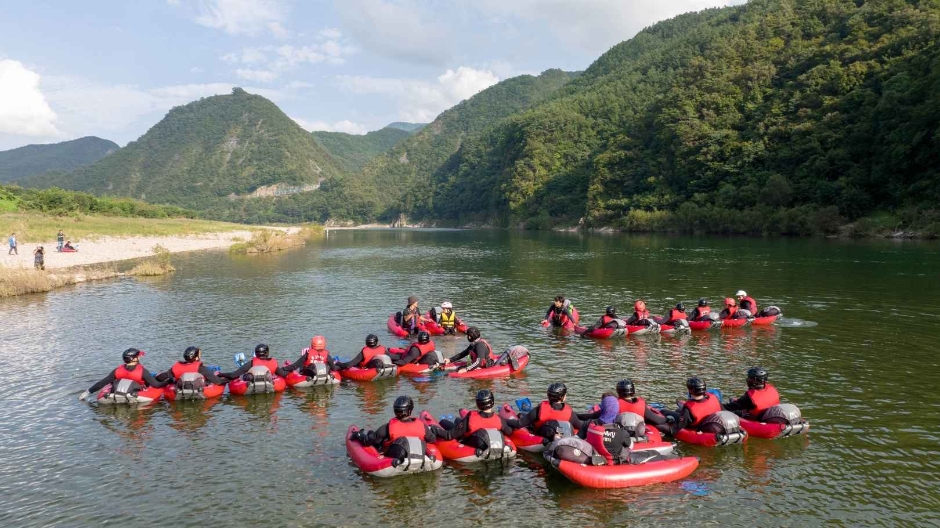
[424,0,940,234]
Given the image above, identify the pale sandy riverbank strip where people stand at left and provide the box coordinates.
[0,228,298,270]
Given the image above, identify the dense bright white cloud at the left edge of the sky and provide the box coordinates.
[0,60,59,136]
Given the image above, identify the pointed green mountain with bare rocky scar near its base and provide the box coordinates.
[24,88,342,219]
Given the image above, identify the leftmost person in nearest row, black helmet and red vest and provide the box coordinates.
[351,396,437,467]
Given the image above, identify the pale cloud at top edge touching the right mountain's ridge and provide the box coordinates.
[467,0,741,55]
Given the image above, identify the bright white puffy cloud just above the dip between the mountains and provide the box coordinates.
[337,66,499,123]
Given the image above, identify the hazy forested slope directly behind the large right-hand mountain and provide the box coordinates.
[361,70,575,218]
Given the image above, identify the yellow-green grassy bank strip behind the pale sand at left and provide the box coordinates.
[0,213,246,243]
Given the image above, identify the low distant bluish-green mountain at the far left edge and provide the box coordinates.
[0,136,120,182]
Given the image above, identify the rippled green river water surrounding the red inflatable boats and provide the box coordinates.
[0,231,940,527]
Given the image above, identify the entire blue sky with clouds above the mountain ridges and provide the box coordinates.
[0,0,742,150]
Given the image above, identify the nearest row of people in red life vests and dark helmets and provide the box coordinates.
[352,367,780,464]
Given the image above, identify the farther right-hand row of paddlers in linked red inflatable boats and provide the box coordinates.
[542,290,779,330]
